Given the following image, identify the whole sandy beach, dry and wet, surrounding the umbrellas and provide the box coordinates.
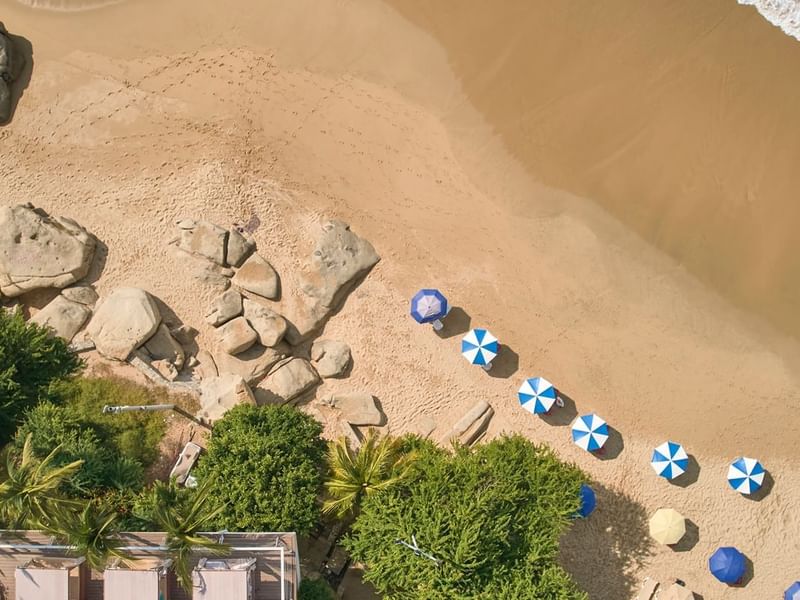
[0,0,800,600]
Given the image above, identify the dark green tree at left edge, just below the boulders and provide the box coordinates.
[0,309,82,445]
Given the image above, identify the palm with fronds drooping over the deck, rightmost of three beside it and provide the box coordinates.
[150,479,228,592]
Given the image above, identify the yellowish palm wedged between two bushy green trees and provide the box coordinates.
[322,429,414,518]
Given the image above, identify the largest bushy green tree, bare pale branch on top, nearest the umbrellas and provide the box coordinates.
[344,436,586,600]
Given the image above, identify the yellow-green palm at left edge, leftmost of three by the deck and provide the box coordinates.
[0,435,83,529]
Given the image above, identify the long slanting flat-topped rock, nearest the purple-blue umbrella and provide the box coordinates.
[284,221,380,345]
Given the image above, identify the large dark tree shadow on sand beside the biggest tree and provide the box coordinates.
[559,484,653,599]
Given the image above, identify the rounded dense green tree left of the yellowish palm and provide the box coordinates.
[196,404,325,533]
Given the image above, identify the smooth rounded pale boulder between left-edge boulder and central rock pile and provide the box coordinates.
[87,287,161,360]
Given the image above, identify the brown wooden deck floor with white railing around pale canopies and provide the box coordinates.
[0,530,300,600]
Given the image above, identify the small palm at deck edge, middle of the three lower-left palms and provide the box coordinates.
[53,503,131,571]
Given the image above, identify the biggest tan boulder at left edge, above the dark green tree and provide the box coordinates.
[0,204,95,297]
